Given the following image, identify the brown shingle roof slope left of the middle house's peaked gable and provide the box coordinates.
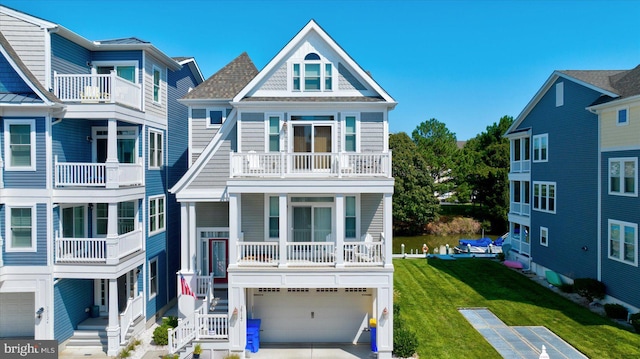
[183,52,258,100]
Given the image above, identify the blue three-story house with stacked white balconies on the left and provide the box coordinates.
[0,6,203,355]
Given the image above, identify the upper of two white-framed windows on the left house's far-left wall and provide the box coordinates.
[4,120,36,171]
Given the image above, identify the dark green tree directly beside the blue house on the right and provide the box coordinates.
[458,116,513,231]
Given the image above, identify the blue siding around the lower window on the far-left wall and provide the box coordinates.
[0,203,47,266]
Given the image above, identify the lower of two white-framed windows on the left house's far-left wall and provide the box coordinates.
[5,206,36,252]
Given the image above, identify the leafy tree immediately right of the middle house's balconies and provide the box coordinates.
[389,132,438,235]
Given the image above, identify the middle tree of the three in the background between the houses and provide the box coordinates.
[411,118,459,198]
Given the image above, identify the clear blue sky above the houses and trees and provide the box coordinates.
[1,0,640,140]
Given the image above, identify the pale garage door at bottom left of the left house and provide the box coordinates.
[0,293,36,338]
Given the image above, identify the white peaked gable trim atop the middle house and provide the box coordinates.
[233,20,396,106]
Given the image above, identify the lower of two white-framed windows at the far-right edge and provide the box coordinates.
[609,219,638,266]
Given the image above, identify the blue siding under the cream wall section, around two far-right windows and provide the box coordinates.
[600,150,640,307]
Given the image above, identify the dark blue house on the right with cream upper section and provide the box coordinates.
[505,69,640,308]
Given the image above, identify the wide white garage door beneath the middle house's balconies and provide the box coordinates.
[253,288,373,343]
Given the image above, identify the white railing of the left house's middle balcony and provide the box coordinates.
[54,156,142,188]
